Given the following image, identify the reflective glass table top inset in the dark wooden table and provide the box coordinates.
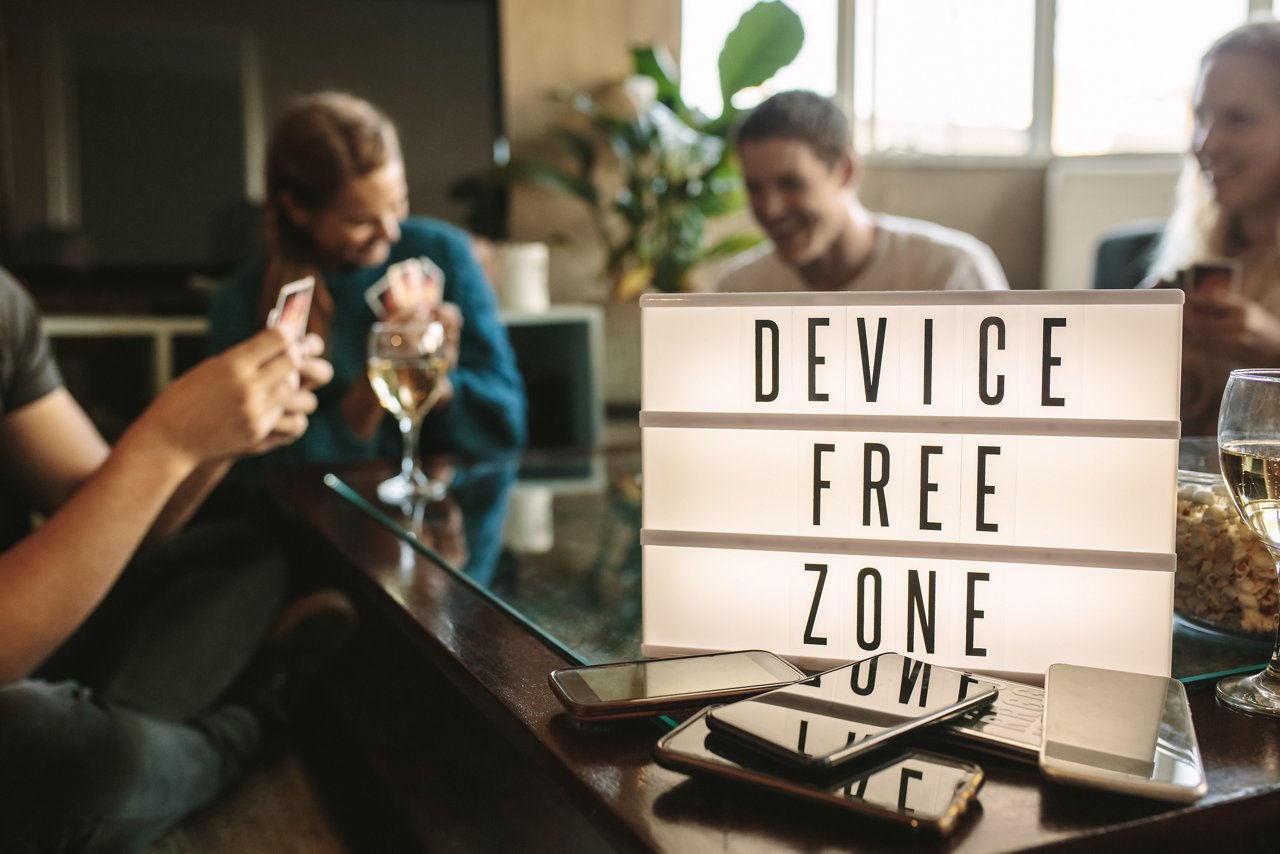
[325,448,1270,684]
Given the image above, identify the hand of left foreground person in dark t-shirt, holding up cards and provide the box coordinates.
[136,329,332,466]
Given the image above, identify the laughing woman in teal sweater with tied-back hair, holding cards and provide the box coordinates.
[210,92,525,461]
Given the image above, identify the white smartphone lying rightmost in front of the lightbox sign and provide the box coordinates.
[1039,665,1208,803]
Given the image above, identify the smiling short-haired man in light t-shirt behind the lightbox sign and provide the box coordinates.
[719,91,1009,292]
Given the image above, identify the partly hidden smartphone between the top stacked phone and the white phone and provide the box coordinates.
[937,676,1044,764]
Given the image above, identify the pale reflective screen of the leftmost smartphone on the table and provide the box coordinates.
[577,654,780,700]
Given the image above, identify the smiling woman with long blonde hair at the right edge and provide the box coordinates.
[1151,19,1280,435]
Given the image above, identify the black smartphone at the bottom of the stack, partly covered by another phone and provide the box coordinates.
[654,709,983,835]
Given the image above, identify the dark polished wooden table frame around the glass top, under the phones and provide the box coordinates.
[270,470,1280,851]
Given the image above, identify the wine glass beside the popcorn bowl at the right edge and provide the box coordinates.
[1216,369,1280,717]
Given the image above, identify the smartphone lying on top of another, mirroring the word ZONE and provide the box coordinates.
[707,653,998,772]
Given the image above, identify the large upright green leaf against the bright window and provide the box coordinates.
[719,0,804,113]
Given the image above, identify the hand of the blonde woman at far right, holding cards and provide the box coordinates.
[1183,292,1280,367]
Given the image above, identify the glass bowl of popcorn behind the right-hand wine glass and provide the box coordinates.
[1174,439,1277,643]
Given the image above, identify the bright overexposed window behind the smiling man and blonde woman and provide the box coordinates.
[681,0,1259,156]
